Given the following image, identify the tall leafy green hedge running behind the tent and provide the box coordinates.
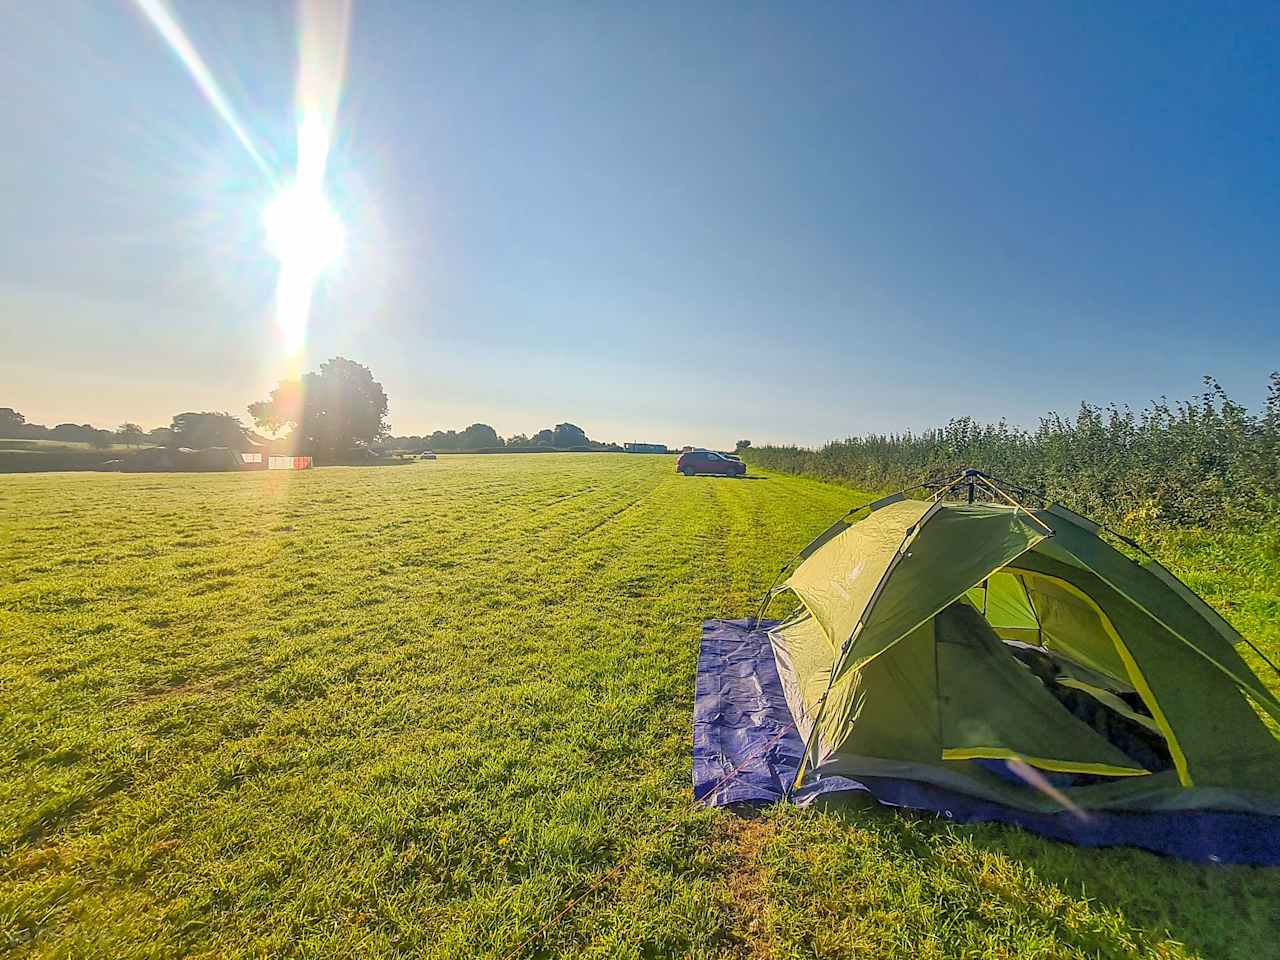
[742,374,1280,527]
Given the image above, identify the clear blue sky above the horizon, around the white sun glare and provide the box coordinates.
[0,0,1280,447]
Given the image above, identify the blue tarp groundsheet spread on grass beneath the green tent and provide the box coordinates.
[694,620,1280,865]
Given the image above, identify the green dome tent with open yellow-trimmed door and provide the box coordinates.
[756,470,1280,817]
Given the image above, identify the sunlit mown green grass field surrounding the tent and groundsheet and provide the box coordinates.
[0,454,1280,960]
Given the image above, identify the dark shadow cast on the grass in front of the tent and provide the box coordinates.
[803,800,1280,960]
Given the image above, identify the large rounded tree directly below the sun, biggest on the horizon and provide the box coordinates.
[248,357,389,457]
